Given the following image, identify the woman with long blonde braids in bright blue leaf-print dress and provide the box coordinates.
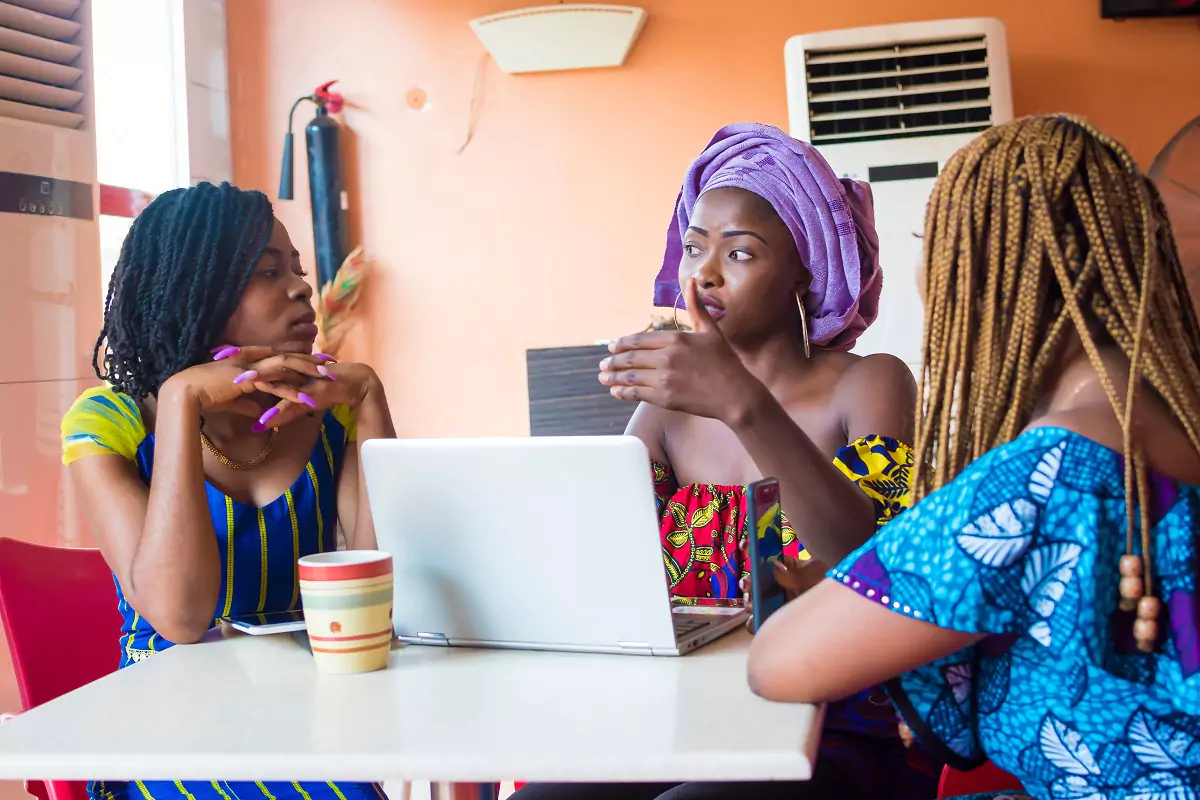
[749,116,1200,800]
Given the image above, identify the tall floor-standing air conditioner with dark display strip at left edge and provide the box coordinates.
[0,0,103,551]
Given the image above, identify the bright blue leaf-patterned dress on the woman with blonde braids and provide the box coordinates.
[829,428,1200,800]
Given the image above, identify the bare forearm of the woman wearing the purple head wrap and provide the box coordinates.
[726,387,875,564]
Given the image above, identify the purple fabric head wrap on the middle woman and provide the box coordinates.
[654,122,883,350]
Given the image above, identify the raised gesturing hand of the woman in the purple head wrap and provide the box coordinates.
[600,279,767,423]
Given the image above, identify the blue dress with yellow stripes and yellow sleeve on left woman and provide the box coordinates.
[62,387,384,800]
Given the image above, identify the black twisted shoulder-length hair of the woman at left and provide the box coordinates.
[91,178,275,399]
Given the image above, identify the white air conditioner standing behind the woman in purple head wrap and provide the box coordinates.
[784,19,1013,372]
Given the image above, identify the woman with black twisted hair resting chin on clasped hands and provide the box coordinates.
[62,184,396,800]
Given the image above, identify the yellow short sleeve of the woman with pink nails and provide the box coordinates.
[62,386,146,464]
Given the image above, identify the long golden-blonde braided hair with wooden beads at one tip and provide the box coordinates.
[913,116,1200,642]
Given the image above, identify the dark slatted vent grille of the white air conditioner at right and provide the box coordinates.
[805,36,992,145]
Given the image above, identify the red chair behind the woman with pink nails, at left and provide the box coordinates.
[0,539,121,800]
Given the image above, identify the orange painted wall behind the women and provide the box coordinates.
[228,0,1200,435]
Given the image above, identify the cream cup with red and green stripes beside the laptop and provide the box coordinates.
[299,551,392,673]
